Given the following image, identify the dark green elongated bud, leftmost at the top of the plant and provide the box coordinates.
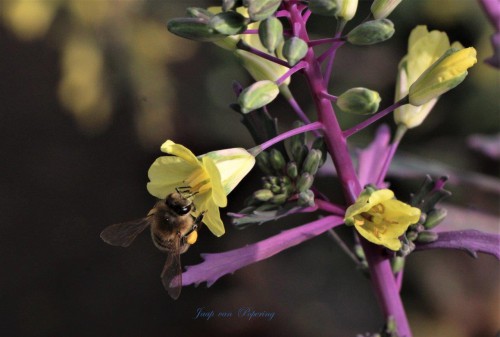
[167,18,226,42]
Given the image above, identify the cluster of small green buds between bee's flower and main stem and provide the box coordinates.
[232,122,327,226]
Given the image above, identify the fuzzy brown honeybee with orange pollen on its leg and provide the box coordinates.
[101,189,204,300]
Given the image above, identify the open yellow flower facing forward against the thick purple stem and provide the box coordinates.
[344,188,420,251]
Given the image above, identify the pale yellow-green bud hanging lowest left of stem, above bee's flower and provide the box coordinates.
[238,80,280,113]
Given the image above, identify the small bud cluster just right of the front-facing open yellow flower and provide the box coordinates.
[400,176,451,256]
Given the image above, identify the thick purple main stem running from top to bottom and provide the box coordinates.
[284,2,412,337]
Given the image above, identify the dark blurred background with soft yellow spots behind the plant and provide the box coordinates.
[0,0,500,337]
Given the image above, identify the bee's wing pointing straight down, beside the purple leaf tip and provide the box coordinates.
[161,237,182,300]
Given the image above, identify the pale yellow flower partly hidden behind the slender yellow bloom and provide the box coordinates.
[394,26,474,128]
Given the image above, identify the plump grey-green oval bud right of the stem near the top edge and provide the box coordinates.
[347,19,395,46]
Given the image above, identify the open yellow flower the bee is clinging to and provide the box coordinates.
[147,140,255,236]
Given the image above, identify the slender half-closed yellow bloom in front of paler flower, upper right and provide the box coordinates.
[409,47,477,106]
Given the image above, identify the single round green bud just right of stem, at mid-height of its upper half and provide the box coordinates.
[337,88,380,115]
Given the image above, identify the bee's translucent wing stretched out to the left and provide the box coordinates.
[101,217,151,247]
